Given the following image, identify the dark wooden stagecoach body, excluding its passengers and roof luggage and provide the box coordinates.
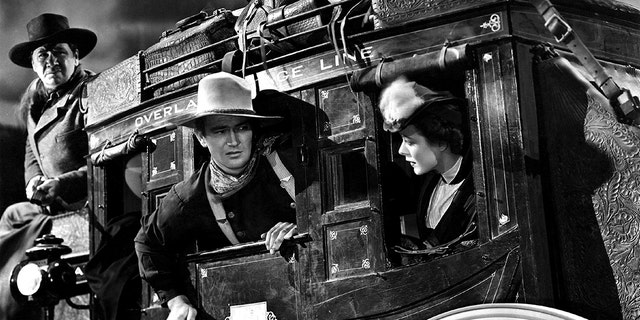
[74,0,640,319]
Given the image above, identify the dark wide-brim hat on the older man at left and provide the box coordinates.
[9,13,98,68]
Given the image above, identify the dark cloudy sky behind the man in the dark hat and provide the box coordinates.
[0,0,247,214]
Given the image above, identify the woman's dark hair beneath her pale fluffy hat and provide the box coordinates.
[409,103,467,155]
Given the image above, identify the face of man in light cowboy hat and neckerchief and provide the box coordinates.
[196,116,253,175]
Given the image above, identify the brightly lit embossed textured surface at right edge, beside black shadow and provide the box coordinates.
[584,86,640,319]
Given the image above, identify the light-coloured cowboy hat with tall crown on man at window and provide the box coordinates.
[171,72,282,128]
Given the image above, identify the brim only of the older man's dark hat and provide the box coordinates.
[9,28,98,68]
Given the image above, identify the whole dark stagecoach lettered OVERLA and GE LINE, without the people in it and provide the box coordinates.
[11,0,640,320]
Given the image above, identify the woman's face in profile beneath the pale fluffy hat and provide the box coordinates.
[398,125,443,175]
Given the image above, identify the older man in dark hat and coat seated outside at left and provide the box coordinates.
[0,13,97,317]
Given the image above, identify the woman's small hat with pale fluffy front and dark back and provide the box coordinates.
[380,77,464,132]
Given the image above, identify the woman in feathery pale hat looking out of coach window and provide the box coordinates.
[380,78,475,249]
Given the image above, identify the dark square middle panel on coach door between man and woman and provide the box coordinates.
[325,147,367,208]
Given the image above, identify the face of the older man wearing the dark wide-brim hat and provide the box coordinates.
[31,43,78,91]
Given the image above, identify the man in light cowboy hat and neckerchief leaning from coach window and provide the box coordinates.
[135,72,296,319]
